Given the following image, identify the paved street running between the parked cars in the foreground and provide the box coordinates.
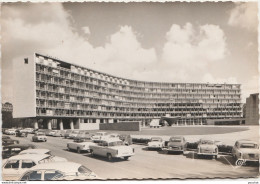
[6,135,258,179]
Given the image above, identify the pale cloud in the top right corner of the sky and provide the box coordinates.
[228,2,258,31]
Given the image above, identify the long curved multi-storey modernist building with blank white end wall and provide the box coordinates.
[14,53,242,129]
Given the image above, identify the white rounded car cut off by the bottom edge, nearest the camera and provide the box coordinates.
[19,162,98,181]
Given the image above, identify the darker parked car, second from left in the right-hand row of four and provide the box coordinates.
[165,136,187,153]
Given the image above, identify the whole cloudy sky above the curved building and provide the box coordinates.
[1,2,259,102]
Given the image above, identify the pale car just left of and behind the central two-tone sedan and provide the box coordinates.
[67,138,96,153]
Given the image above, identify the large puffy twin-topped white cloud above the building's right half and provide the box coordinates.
[162,23,227,82]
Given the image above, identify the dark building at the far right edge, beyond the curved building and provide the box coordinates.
[246,93,259,125]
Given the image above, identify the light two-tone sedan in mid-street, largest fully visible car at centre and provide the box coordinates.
[89,139,134,161]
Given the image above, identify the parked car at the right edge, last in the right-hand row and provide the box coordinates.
[232,140,259,165]
